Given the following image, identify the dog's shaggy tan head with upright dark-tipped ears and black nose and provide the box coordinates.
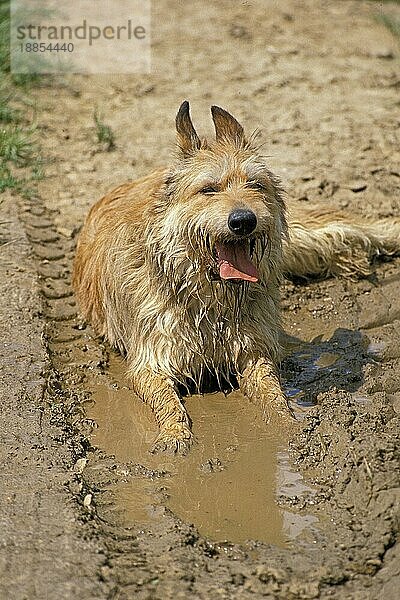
[163,102,287,290]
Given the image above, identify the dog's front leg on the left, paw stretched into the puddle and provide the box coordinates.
[133,370,193,454]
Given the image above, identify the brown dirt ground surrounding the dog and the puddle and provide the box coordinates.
[0,0,400,600]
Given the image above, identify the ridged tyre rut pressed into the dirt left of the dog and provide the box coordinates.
[19,197,153,598]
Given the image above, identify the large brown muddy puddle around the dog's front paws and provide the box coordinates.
[88,356,309,546]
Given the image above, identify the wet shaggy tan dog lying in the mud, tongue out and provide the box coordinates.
[73,102,400,453]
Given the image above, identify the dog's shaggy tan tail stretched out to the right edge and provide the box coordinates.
[283,209,400,278]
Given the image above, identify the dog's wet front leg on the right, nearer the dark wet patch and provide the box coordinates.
[240,358,295,424]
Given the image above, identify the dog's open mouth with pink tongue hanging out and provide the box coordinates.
[216,243,258,281]
